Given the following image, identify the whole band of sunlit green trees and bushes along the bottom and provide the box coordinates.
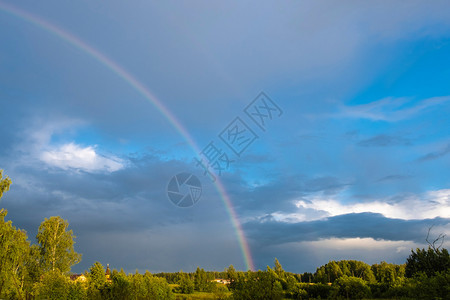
[0,170,450,300]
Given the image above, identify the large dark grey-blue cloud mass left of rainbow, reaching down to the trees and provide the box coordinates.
[1,153,250,271]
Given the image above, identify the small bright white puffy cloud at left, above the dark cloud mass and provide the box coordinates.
[40,143,124,172]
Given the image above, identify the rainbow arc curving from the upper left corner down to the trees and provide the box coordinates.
[0,2,254,270]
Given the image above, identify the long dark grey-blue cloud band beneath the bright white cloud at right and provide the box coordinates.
[244,213,450,245]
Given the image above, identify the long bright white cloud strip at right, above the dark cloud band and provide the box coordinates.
[292,189,450,221]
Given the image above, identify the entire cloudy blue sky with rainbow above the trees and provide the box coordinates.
[0,0,450,273]
